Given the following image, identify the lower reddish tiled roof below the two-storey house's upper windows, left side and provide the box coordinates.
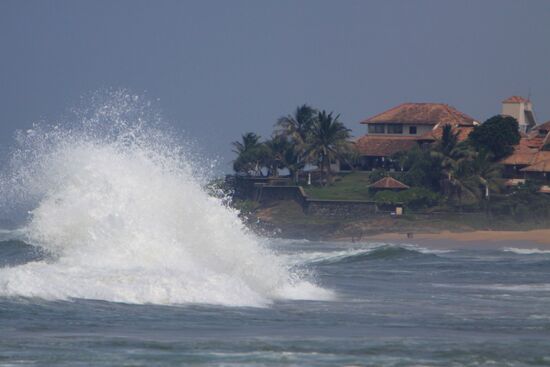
[355,135,418,157]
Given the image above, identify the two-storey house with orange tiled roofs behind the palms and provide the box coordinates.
[355,103,478,170]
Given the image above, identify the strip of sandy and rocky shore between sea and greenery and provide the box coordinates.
[252,201,550,249]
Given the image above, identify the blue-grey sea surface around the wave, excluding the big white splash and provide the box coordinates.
[0,241,550,366]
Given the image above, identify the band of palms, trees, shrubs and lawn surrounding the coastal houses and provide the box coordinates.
[227,105,550,233]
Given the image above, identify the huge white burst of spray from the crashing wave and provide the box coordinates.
[0,92,330,306]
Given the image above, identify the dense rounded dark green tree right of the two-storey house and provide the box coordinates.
[469,115,521,159]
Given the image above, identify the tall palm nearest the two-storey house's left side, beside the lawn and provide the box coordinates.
[307,110,351,187]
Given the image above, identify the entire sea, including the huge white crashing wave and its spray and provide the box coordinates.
[0,92,550,366]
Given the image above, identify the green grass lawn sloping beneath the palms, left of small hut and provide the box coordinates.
[303,172,372,200]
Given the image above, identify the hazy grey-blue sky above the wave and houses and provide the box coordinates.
[0,0,550,172]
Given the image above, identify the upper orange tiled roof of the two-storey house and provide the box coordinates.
[361,103,475,125]
